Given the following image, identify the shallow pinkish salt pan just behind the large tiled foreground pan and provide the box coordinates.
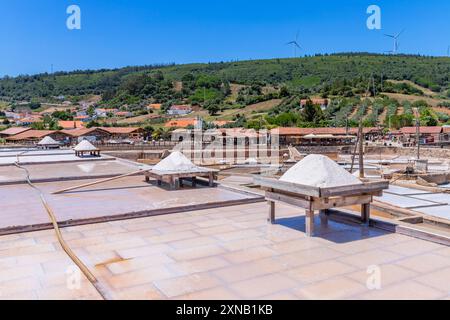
[0,176,253,228]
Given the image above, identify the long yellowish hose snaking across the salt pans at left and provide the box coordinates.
[15,151,110,300]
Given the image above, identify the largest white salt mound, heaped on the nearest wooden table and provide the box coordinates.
[280,154,362,188]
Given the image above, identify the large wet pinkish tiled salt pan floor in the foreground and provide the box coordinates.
[0,203,450,300]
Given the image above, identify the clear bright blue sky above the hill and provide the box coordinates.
[0,0,450,75]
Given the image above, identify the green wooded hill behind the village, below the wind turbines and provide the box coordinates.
[0,53,450,129]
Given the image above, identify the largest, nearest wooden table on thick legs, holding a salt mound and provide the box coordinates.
[254,176,389,237]
